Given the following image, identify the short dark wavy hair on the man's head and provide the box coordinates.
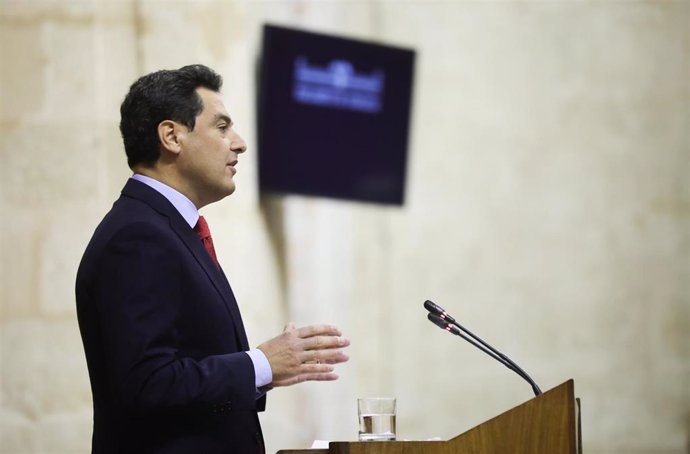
[120,65,223,168]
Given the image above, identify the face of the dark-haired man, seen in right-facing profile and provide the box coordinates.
[177,88,247,208]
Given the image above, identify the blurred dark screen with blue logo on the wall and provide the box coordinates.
[257,25,415,205]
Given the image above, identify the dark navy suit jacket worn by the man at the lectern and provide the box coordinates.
[76,180,265,454]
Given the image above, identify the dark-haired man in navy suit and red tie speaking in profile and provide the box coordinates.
[76,65,349,454]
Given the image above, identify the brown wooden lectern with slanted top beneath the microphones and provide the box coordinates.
[278,380,582,454]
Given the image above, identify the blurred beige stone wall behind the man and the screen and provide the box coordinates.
[0,0,690,454]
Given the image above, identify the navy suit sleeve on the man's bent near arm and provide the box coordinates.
[88,223,256,412]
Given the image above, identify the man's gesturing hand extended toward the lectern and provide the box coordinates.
[258,323,350,386]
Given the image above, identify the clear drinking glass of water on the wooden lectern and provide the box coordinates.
[357,397,395,441]
